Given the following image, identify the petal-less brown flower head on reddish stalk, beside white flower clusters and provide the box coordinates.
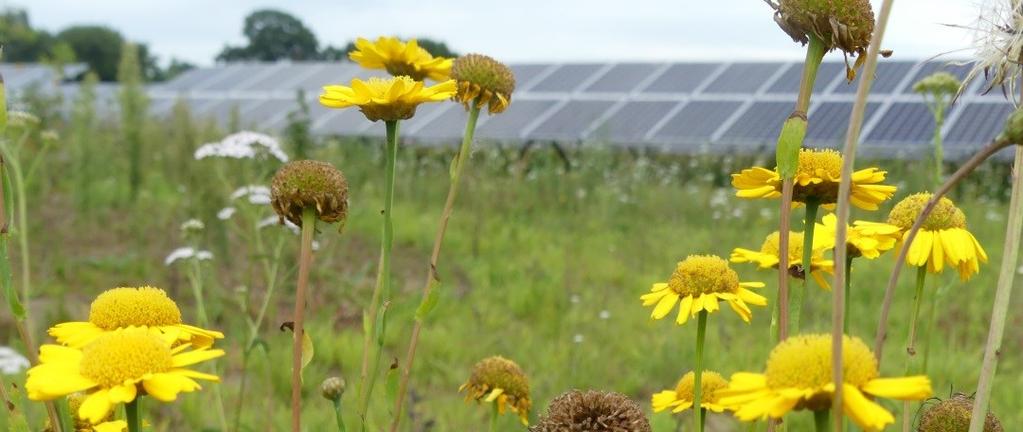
[270,161,348,226]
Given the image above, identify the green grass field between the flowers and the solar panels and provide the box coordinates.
[0,100,1023,431]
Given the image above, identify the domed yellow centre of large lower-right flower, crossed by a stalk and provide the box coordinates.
[766,334,878,390]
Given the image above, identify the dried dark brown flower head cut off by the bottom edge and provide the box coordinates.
[530,390,651,432]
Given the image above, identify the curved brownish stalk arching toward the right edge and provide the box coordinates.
[875,137,1013,364]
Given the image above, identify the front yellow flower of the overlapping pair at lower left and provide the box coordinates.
[25,328,224,423]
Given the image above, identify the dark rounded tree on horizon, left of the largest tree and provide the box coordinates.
[57,26,124,81]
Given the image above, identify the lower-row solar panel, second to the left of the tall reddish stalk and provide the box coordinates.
[654,100,743,143]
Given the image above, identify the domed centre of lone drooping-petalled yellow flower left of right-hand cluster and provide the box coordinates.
[668,255,739,296]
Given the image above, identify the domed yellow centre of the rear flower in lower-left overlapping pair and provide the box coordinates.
[89,287,181,330]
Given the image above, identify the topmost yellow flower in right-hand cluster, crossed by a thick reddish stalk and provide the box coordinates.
[731,148,895,210]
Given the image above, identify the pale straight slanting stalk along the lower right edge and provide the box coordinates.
[970,146,1023,432]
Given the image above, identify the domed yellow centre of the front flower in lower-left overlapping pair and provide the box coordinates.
[79,330,172,388]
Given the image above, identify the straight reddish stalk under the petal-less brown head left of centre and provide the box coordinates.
[292,207,316,432]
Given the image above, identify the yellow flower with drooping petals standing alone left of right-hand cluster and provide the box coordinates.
[639,255,767,326]
